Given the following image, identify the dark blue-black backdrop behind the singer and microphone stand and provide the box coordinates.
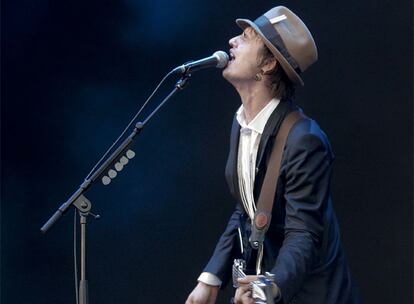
[1,0,413,304]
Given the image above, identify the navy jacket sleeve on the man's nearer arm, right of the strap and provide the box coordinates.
[272,126,333,303]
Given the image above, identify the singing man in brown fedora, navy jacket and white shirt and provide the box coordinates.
[186,6,358,304]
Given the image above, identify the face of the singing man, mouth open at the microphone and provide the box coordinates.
[223,27,264,84]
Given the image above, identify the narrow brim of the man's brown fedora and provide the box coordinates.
[236,19,304,86]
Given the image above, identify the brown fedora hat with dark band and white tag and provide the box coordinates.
[236,6,318,85]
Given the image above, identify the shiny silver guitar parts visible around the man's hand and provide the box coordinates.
[233,259,274,304]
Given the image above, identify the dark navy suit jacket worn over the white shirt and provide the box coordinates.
[204,101,359,304]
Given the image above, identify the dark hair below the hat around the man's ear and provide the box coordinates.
[258,44,295,100]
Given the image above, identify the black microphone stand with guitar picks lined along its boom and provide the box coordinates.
[40,70,191,304]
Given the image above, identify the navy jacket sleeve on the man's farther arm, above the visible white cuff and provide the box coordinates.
[203,204,243,288]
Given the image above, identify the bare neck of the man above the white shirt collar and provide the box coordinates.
[236,81,273,123]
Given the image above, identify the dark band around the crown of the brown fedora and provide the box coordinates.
[254,15,302,74]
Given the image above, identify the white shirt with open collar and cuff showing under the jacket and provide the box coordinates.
[198,98,280,286]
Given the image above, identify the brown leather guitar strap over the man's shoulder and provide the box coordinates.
[250,111,305,249]
